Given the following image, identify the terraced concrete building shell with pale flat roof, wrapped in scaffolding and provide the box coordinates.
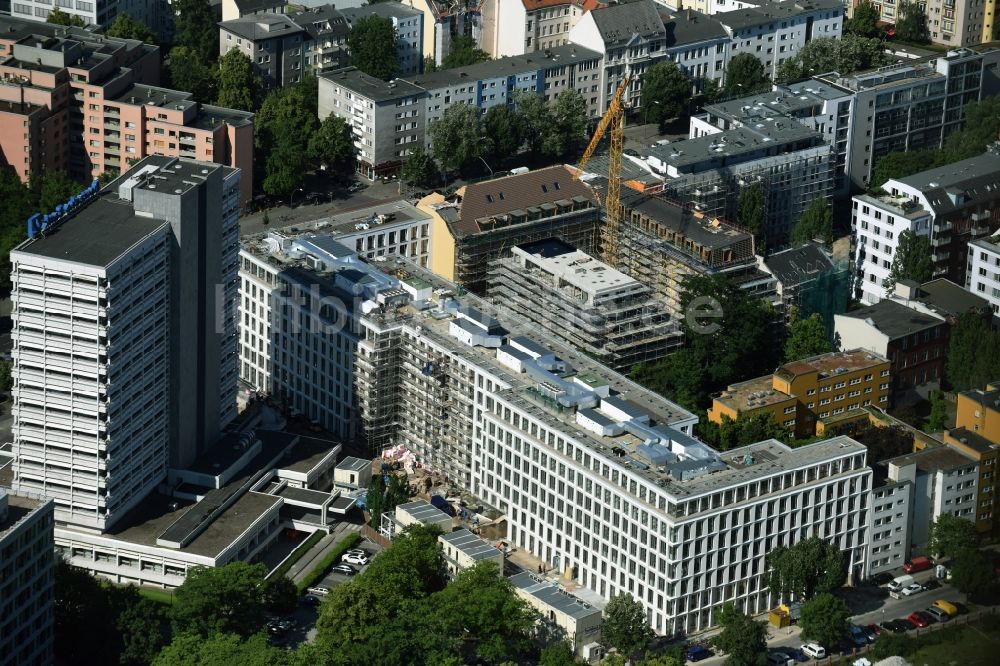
[488,239,683,370]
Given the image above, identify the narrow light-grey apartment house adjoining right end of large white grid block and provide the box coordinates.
[868,477,913,576]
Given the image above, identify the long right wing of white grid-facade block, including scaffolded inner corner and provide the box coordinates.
[357,255,871,634]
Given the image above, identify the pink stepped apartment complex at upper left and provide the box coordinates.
[0,16,253,204]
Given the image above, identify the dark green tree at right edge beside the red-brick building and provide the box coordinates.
[945,312,1000,391]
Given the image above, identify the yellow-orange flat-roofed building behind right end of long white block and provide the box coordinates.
[708,349,892,437]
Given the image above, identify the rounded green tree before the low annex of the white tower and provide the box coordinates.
[170,561,275,637]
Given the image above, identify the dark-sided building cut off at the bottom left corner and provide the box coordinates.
[0,488,55,666]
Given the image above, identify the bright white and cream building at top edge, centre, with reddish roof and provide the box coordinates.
[481,0,604,58]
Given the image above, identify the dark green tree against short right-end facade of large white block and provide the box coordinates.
[767,537,847,600]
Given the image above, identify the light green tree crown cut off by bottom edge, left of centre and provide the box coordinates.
[153,633,289,666]
